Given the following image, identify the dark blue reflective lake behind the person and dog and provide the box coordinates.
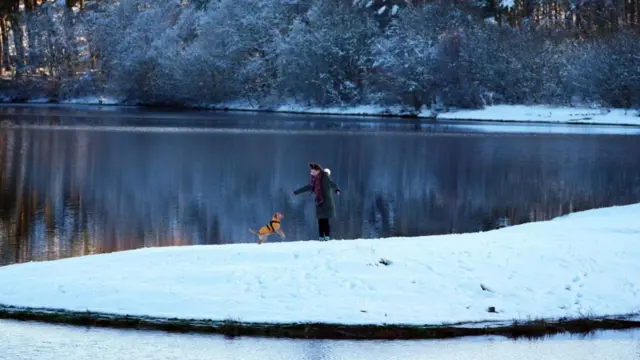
[0,106,640,265]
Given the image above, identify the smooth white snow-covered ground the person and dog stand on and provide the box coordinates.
[0,204,640,324]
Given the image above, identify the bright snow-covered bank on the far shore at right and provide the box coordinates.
[438,105,640,126]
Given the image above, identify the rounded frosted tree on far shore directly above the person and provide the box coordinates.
[278,0,379,105]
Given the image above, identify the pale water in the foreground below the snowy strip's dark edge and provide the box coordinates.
[0,320,640,360]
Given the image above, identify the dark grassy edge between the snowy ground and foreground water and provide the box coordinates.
[0,305,640,340]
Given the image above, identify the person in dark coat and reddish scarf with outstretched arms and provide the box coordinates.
[293,164,340,241]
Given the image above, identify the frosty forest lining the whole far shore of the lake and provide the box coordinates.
[0,0,640,109]
